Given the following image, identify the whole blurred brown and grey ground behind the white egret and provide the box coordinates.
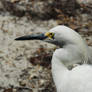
[0,0,92,92]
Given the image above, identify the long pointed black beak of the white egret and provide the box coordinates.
[15,34,47,40]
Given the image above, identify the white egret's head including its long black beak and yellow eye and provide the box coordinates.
[15,25,85,47]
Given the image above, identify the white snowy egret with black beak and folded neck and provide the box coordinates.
[16,25,92,92]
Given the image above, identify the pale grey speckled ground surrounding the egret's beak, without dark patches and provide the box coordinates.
[0,15,57,92]
